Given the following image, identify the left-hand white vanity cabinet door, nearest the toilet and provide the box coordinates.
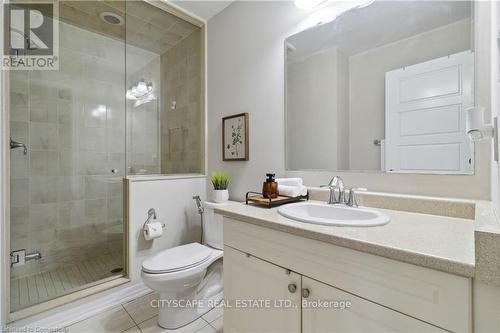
[224,246,301,333]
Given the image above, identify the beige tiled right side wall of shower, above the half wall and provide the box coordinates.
[160,29,204,174]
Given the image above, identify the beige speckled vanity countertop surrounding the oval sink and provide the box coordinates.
[216,197,477,277]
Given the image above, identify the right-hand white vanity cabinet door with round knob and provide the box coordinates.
[302,276,446,333]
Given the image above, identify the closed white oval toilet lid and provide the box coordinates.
[142,243,212,273]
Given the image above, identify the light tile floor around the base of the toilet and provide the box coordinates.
[67,293,223,333]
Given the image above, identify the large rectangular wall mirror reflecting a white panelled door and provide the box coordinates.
[285,1,474,174]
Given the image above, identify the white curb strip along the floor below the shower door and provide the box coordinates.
[8,282,152,329]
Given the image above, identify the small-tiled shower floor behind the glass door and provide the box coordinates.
[10,255,123,311]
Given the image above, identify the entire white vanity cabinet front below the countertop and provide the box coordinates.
[224,218,472,333]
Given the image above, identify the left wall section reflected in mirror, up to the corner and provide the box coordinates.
[286,48,347,170]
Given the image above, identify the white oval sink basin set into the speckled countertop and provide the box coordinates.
[278,202,391,227]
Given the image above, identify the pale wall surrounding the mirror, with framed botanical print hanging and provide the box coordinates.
[207,1,491,199]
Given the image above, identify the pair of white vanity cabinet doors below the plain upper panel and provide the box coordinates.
[224,246,445,333]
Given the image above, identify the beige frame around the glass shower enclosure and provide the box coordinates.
[0,0,207,322]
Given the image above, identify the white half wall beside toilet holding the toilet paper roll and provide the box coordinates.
[128,175,206,282]
